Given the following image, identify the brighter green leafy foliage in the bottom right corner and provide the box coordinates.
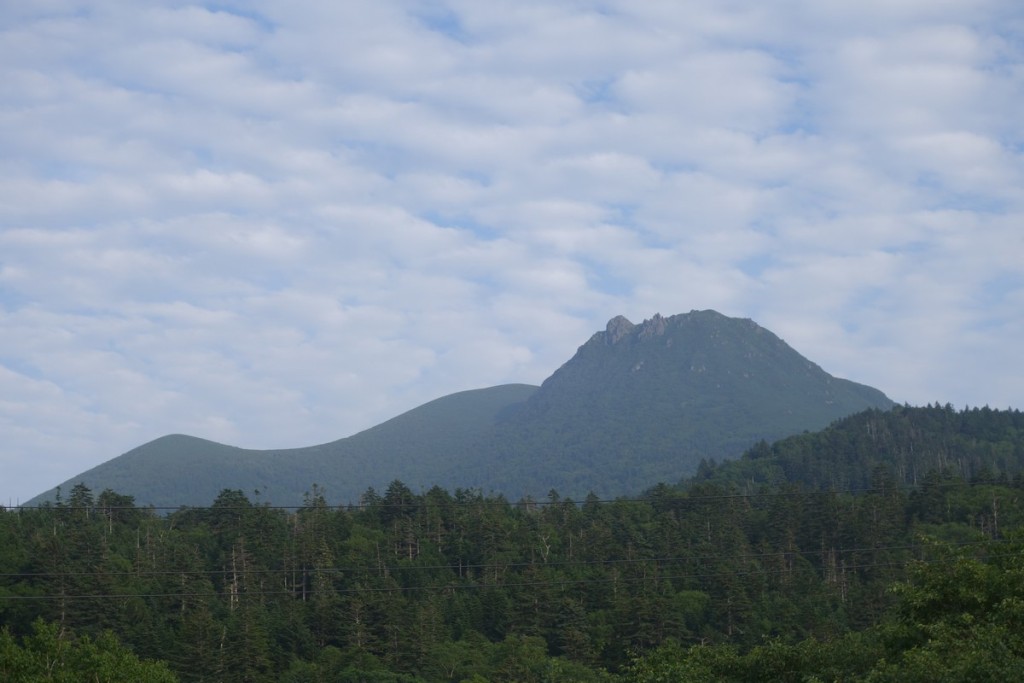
[627,543,1024,683]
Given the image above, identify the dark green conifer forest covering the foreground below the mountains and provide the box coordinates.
[0,407,1024,683]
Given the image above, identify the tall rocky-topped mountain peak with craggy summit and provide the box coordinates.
[481,310,893,495]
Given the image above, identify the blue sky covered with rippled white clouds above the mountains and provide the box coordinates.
[0,0,1024,505]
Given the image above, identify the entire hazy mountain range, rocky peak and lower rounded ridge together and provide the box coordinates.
[30,310,893,507]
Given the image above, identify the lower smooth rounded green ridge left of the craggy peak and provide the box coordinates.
[28,384,537,507]
